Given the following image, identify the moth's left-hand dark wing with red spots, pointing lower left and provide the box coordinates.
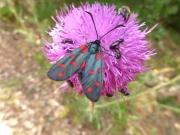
[48,45,89,81]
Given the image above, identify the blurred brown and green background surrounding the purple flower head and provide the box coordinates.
[0,0,180,135]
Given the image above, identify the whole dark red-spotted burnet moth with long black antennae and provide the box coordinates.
[48,11,124,102]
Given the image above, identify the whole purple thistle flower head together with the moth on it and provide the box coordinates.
[42,2,157,102]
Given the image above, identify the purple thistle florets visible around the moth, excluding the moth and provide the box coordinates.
[42,2,156,100]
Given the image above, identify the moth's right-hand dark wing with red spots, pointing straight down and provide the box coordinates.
[78,47,103,102]
